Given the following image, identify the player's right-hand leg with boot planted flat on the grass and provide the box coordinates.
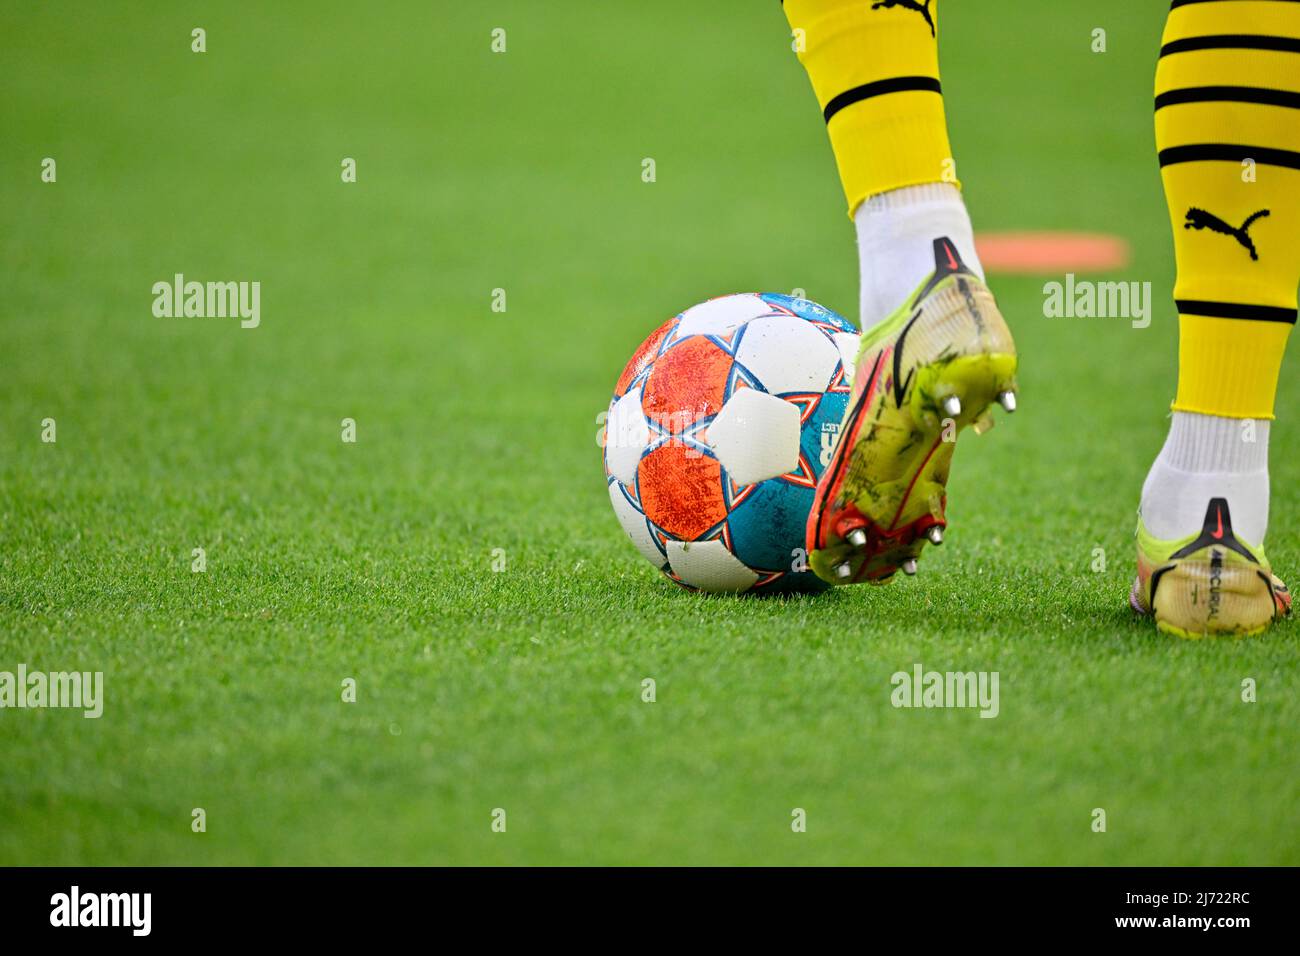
[1130,0,1300,636]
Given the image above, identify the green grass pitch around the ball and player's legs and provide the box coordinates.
[0,0,1300,864]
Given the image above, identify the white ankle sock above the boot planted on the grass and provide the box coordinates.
[1140,411,1269,546]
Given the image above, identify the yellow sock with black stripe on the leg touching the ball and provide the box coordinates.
[784,0,956,217]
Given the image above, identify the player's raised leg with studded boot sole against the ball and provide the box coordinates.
[784,0,1015,584]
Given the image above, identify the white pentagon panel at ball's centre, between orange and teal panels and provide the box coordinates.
[709,387,800,485]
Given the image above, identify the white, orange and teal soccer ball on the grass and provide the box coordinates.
[603,293,858,592]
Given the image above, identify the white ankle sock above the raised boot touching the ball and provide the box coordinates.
[853,182,984,332]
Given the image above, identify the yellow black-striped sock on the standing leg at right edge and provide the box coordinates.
[1156,0,1300,418]
